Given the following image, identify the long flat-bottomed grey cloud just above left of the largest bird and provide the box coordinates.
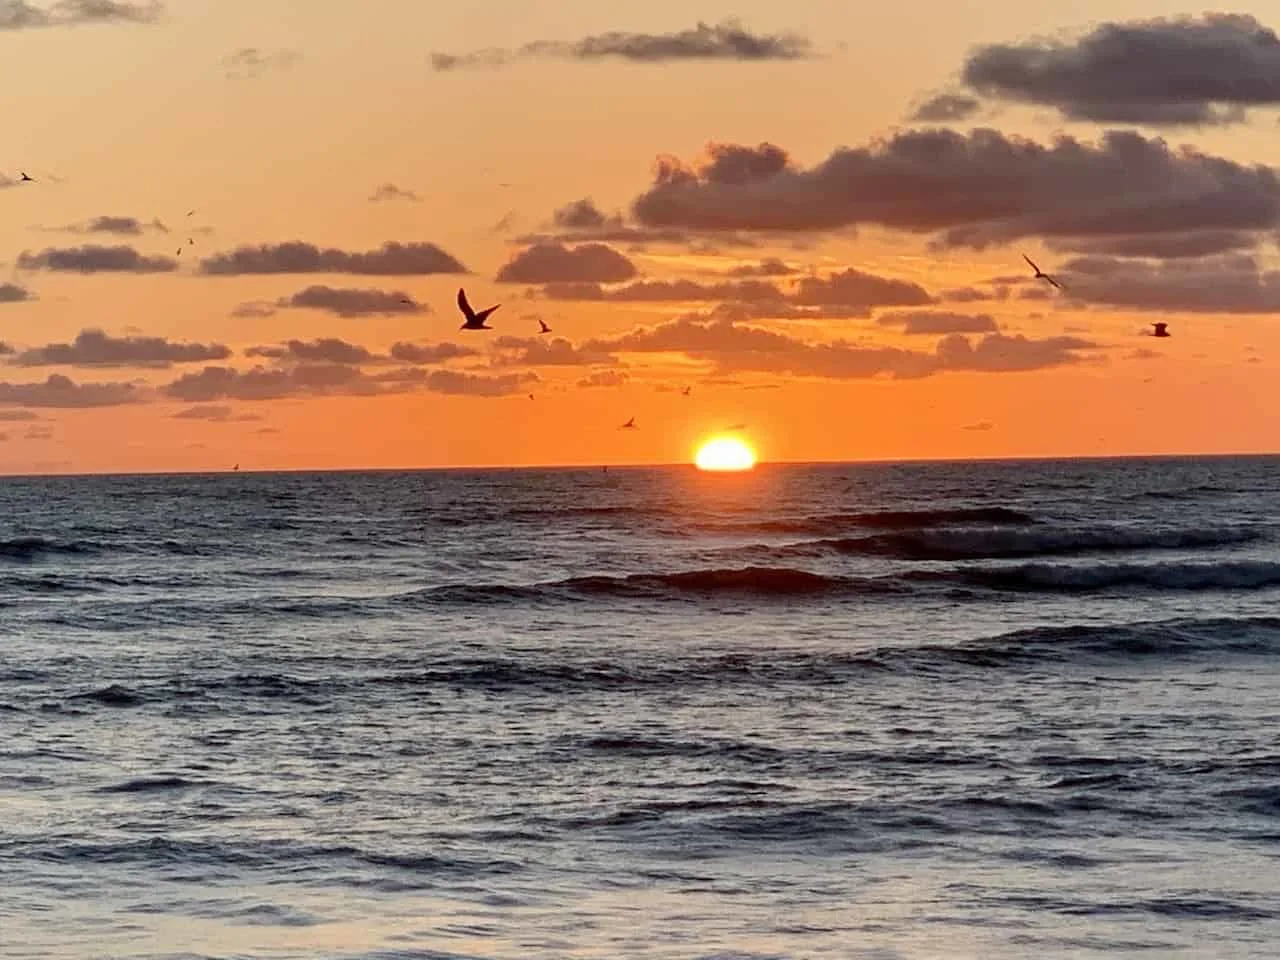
[200,241,467,276]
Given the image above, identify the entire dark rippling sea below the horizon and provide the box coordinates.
[0,458,1280,960]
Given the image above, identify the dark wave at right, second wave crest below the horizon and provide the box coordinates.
[793,526,1262,561]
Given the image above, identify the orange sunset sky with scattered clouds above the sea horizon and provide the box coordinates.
[0,0,1280,474]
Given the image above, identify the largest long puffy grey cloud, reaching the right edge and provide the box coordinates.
[632,128,1280,250]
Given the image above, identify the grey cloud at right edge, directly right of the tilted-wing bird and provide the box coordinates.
[1059,253,1280,314]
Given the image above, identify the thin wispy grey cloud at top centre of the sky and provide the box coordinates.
[431,20,812,70]
